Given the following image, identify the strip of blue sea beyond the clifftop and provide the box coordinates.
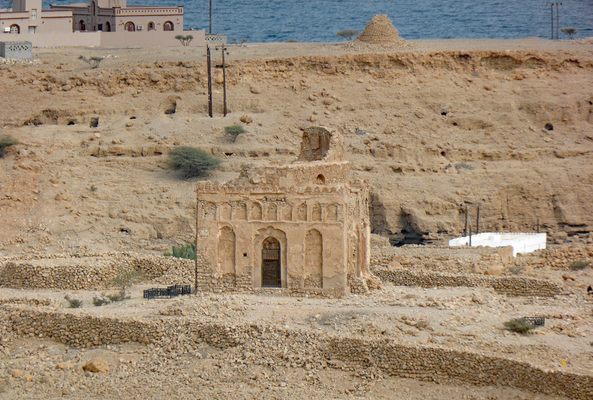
[0,0,593,42]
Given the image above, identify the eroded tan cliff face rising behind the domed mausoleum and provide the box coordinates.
[0,44,593,252]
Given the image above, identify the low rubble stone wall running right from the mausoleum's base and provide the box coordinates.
[373,267,562,297]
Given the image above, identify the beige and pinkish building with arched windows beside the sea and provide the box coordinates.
[0,0,194,47]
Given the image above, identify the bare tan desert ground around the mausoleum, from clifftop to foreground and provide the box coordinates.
[0,32,593,399]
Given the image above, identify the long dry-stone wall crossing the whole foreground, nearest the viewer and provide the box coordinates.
[0,306,593,400]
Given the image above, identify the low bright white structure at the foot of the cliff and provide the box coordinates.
[449,232,547,256]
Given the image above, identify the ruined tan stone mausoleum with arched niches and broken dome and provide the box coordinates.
[197,127,370,295]
